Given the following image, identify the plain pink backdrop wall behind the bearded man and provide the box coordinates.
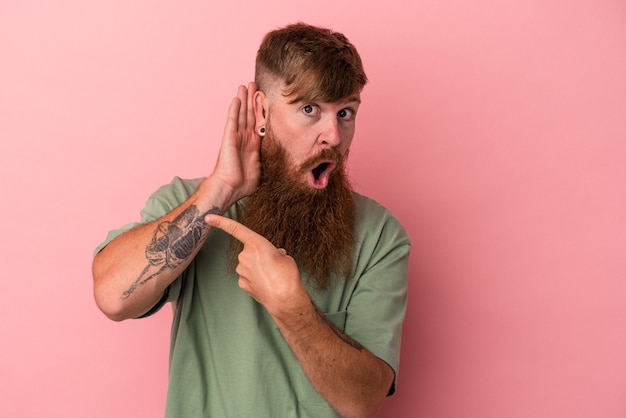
[0,0,626,418]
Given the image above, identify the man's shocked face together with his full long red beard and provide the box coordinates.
[232,88,359,289]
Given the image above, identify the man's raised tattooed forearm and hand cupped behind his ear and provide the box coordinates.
[93,83,261,321]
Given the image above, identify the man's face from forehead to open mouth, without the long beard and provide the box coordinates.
[267,94,360,190]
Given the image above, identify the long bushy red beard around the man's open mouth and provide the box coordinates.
[231,129,355,290]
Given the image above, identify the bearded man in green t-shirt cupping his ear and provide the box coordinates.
[93,24,410,418]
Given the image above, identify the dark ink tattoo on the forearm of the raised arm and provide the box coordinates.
[121,205,219,300]
